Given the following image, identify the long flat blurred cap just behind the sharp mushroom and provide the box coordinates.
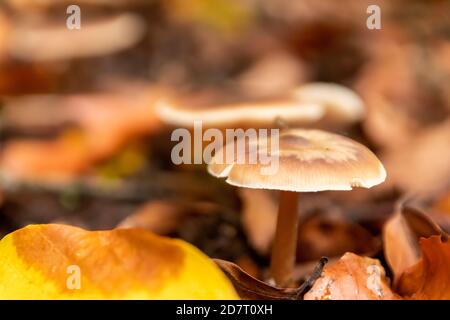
[156,95,325,127]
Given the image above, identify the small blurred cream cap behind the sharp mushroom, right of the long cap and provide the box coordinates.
[293,82,364,123]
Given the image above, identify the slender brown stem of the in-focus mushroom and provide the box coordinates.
[270,191,298,287]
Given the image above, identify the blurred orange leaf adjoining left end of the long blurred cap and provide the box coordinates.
[66,87,165,159]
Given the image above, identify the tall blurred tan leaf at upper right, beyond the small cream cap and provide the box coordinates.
[355,34,418,148]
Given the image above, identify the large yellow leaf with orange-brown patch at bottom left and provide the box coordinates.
[0,224,237,299]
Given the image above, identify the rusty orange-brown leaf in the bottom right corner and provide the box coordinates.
[398,236,450,300]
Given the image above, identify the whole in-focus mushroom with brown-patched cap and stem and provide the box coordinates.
[208,129,386,286]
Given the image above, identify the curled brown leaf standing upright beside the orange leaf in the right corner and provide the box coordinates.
[383,207,447,285]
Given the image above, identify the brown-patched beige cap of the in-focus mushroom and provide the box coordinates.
[208,129,386,192]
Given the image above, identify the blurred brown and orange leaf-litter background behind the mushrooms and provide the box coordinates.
[0,0,450,279]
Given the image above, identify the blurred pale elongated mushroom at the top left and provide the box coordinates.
[8,13,145,61]
